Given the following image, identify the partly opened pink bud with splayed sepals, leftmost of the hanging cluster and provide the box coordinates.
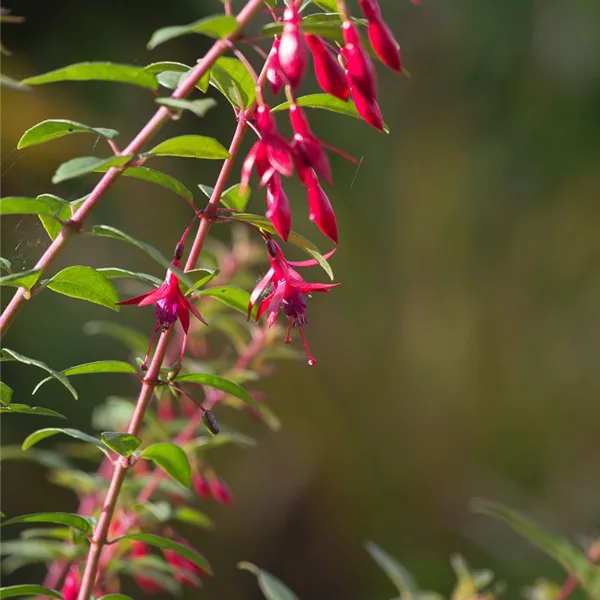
[241,104,294,192]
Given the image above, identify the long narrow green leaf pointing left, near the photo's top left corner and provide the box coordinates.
[21,62,158,90]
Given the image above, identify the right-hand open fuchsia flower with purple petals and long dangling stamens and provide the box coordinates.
[248,239,340,365]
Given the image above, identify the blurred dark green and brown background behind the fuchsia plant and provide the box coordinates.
[0,0,600,600]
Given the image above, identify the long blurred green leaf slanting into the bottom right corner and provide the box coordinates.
[471,498,600,598]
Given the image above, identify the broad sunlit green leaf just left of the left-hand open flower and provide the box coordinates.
[47,266,119,312]
